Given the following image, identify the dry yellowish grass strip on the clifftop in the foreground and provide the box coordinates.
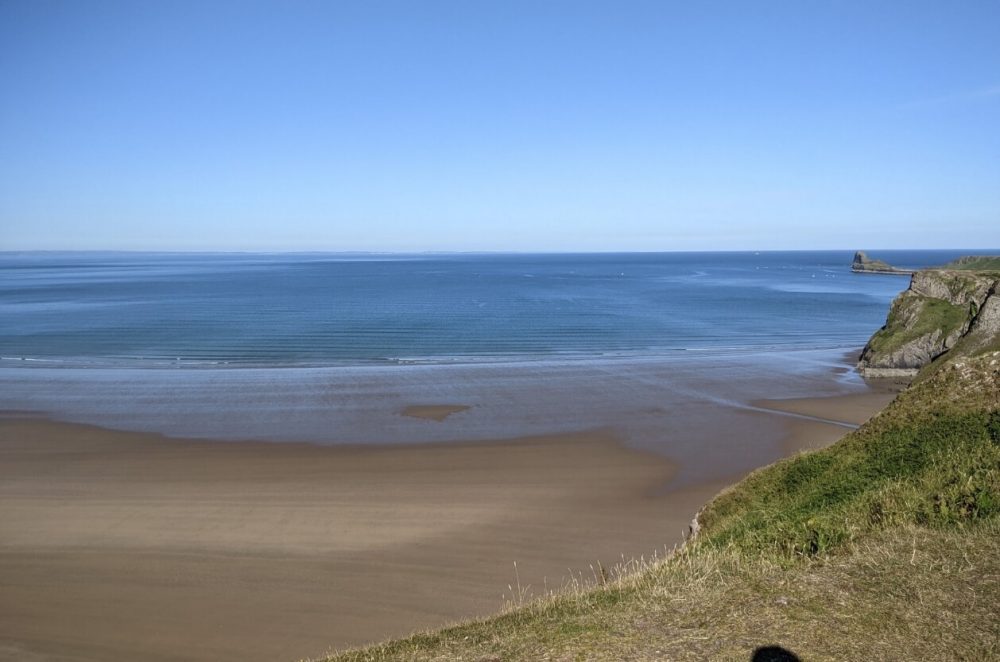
[329,522,1000,662]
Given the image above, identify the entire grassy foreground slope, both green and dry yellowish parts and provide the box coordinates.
[322,354,1000,660]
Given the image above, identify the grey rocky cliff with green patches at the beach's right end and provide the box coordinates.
[858,270,1000,377]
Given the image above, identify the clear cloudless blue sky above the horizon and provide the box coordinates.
[0,0,1000,251]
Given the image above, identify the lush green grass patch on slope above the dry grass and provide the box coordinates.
[702,364,1000,561]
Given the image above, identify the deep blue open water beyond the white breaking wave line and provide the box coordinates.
[0,251,970,367]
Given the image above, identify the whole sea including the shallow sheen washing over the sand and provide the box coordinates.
[0,249,983,480]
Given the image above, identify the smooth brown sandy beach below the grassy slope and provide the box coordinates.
[0,393,886,661]
